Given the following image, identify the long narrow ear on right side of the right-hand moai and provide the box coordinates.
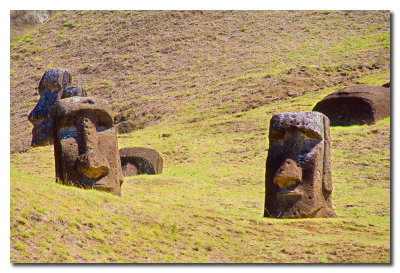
[322,115,333,197]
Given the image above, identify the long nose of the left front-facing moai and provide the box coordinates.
[77,117,110,179]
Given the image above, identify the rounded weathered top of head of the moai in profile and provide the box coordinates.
[38,68,71,94]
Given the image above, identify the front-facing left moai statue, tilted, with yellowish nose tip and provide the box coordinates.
[52,97,123,195]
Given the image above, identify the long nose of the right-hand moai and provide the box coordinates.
[274,131,305,188]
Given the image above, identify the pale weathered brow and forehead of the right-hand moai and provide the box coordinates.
[269,112,324,141]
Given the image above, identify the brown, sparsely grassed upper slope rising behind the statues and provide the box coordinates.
[10,11,390,152]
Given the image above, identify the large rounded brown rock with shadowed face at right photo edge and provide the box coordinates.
[313,84,390,126]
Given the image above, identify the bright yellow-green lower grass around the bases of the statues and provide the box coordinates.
[10,85,391,263]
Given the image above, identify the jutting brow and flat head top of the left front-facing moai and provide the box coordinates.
[53,97,114,128]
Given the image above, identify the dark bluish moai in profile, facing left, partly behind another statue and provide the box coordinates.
[28,69,71,147]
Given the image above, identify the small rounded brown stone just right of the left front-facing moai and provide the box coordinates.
[119,147,163,176]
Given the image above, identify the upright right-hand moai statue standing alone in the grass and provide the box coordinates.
[264,112,336,218]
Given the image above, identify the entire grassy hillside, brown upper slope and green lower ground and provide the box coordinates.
[10,11,390,263]
